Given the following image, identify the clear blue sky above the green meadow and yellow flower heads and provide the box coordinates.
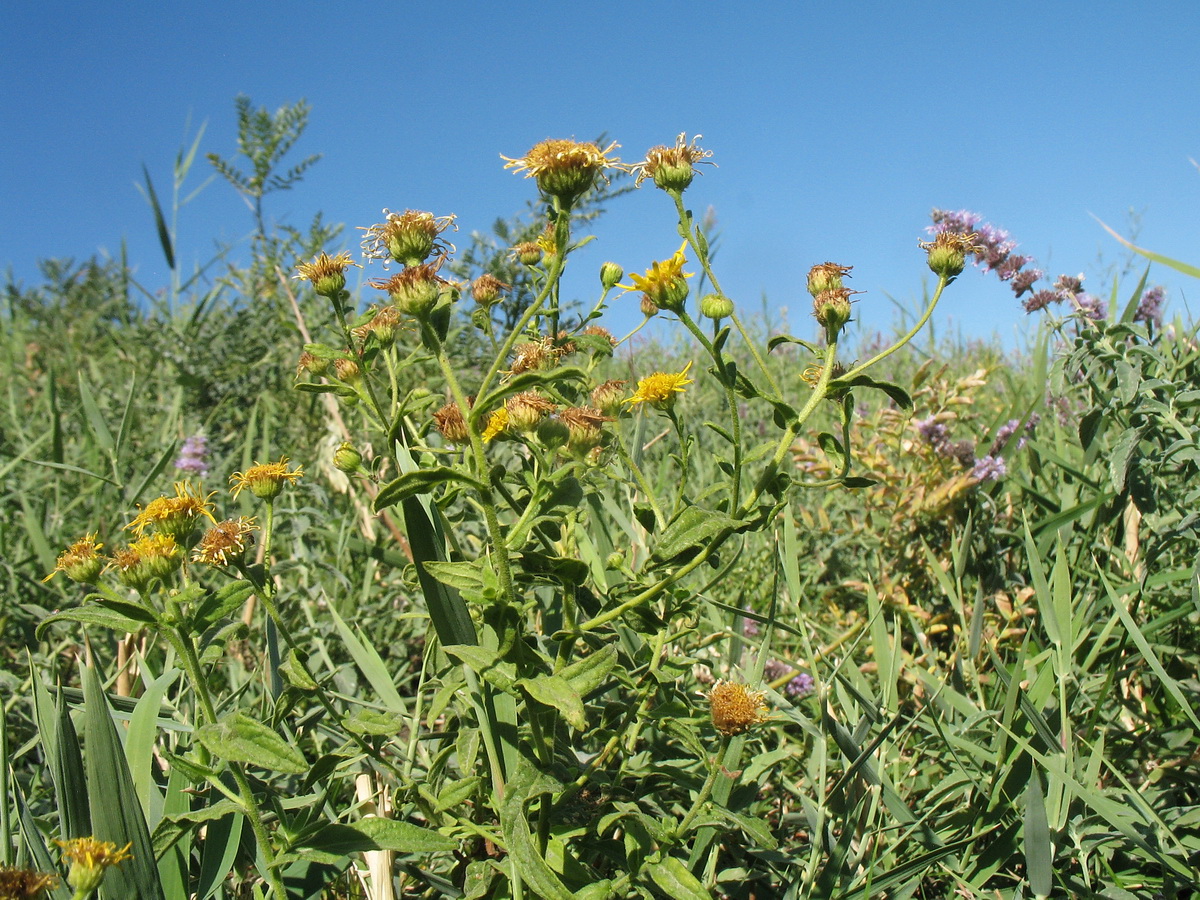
[0,0,1200,342]
